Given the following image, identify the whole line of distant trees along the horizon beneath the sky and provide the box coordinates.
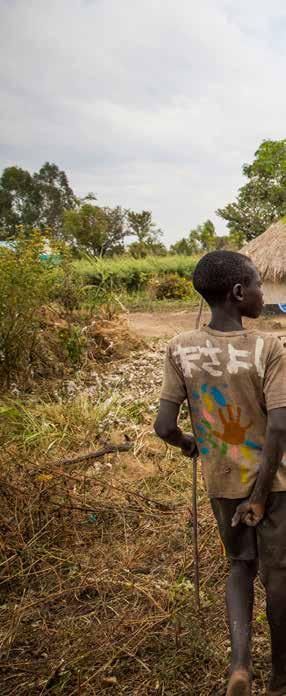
[0,139,286,258]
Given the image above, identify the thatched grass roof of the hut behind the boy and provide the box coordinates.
[241,218,286,283]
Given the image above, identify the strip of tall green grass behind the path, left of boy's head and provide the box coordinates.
[74,255,198,292]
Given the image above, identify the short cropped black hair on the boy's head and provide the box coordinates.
[193,250,253,306]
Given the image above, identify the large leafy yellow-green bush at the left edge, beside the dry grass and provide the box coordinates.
[0,230,94,386]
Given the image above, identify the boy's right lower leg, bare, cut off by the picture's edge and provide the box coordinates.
[263,568,286,696]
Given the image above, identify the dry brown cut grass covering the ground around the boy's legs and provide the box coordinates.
[0,328,269,696]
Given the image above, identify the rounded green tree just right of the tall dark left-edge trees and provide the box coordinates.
[63,203,126,256]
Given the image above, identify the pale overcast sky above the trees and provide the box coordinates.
[0,0,286,244]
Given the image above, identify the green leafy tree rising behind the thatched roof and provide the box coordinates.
[217,139,286,241]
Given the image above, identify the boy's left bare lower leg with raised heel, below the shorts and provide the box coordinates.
[226,560,257,696]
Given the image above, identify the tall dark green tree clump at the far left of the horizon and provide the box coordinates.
[0,162,77,239]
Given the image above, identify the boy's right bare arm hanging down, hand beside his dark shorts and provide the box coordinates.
[232,408,286,527]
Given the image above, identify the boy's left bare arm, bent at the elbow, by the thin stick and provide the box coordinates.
[154,399,197,457]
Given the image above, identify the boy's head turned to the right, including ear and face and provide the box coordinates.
[193,251,263,318]
